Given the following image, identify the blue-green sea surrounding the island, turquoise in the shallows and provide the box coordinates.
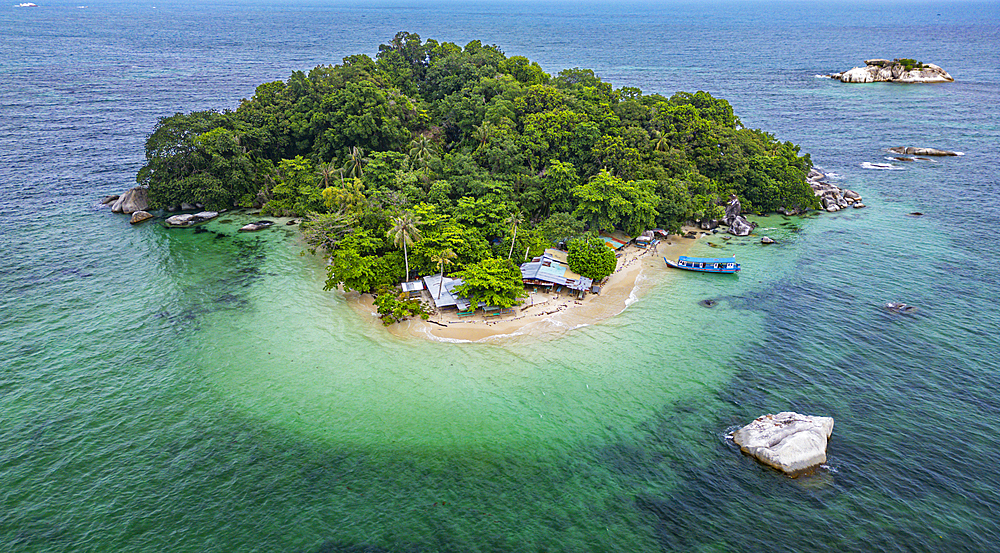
[0,0,1000,553]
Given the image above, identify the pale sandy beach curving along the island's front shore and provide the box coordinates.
[346,228,705,342]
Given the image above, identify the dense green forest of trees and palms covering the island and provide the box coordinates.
[137,32,818,303]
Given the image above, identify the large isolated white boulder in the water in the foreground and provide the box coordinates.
[733,411,833,476]
